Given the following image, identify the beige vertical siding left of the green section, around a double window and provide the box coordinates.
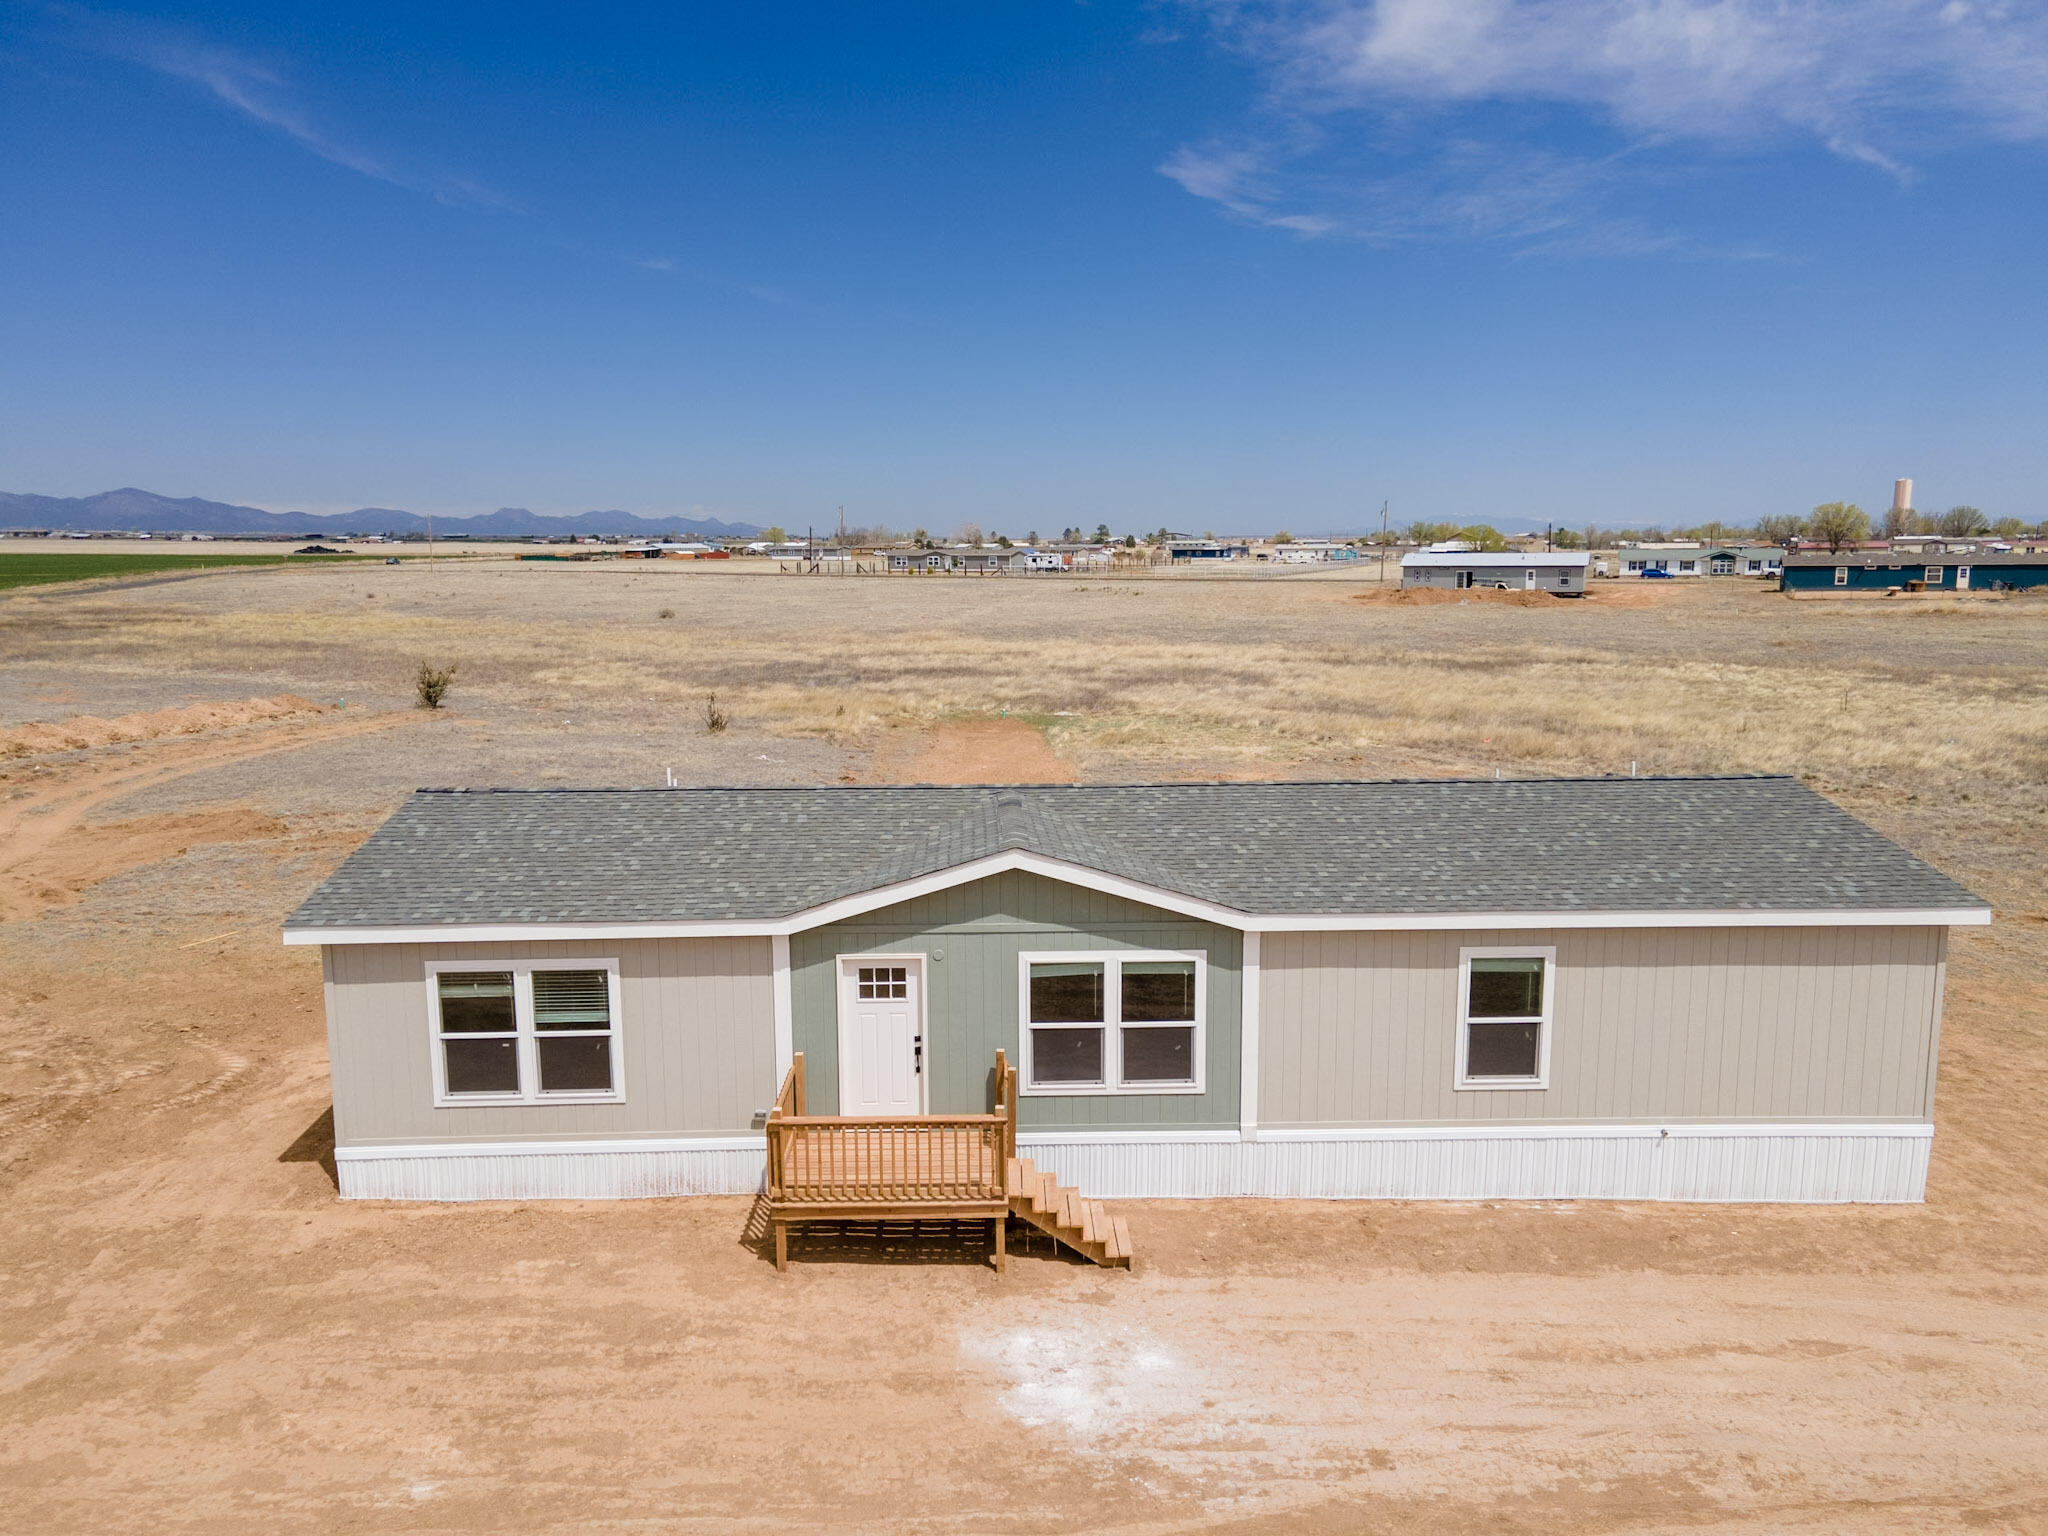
[326,938,776,1147]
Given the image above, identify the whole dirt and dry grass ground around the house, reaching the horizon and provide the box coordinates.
[0,567,2048,1534]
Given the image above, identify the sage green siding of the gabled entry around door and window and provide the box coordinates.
[791,870,1243,1128]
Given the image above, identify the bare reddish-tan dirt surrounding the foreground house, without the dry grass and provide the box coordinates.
[12,573,2048,1536]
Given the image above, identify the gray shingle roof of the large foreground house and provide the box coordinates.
[289,778,1982,928]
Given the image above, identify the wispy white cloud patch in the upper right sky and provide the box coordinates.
[1159,0,2048,250]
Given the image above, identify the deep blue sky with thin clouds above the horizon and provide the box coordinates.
[0,0,2048,532]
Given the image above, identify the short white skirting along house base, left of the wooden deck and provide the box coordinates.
[334,1137,768,1200]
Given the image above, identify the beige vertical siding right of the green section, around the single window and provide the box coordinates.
[1260,928,1948,1126]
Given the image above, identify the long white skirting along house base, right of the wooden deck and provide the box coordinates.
[1018,1124,1933,1204]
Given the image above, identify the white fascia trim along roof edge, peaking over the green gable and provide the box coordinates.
[285,850,1991,944]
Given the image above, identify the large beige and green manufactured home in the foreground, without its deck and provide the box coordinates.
[285,778,1991,1200]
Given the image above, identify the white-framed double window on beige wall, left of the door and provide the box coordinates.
[428,961,618,1104]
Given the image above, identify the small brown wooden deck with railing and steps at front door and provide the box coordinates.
[768,1051,1130,1270]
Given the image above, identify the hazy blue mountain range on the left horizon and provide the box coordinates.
[0,487,762,539]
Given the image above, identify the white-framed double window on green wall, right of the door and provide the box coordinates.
[1020,954,1204,1094]
